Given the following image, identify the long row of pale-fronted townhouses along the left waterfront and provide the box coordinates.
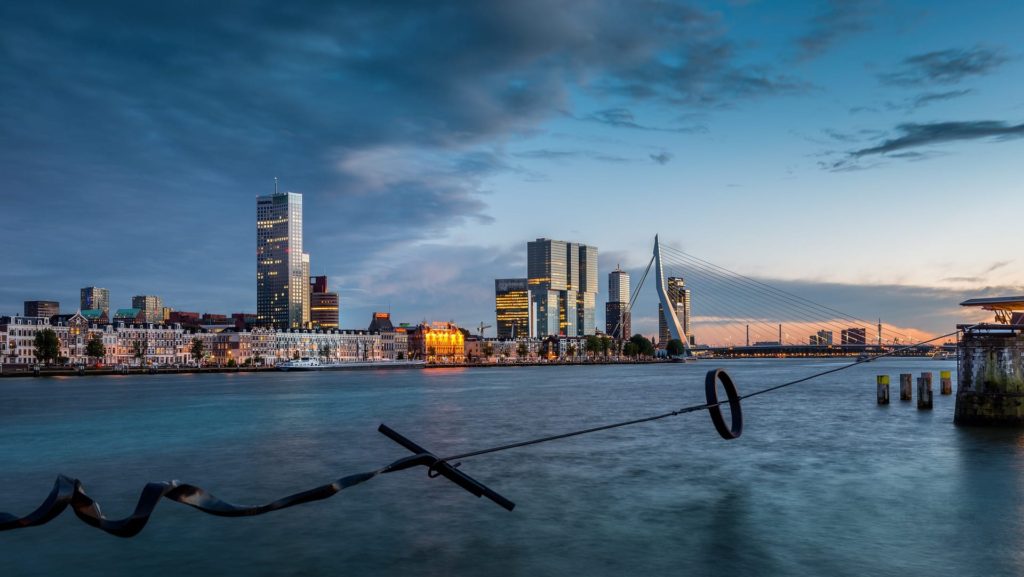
[0,314,408,366]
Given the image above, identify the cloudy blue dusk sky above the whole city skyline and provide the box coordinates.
[0,0,1024,334]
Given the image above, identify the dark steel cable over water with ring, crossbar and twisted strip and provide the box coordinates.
[0,327,971,537]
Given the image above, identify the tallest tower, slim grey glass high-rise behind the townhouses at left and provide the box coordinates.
[256,191,309,329]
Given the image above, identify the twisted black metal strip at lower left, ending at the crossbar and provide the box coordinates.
[0,455,423,537]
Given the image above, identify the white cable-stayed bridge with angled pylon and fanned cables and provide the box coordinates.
[630,236,946,357]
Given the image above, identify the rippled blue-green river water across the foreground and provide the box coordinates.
[0,359,1024,577]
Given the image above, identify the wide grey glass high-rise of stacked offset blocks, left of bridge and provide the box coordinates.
[526,239,598,337]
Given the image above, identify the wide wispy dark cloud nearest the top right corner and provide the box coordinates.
[879,46,1010,86]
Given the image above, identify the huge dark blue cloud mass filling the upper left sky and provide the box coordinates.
[0,0,805,310]
